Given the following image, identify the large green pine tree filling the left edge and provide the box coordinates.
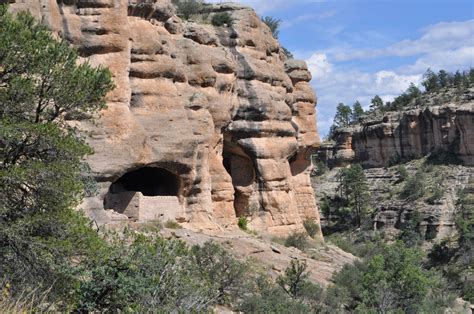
[0,6,113,300]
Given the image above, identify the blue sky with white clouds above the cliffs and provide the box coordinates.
[213,0,474,137]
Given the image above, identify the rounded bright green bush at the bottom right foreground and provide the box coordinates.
[325,242,449,313]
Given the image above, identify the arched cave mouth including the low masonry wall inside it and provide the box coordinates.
[104,167,181,221]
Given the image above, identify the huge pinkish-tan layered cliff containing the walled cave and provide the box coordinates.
[11,0,319,234]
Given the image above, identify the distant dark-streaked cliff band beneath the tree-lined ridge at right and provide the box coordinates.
[319,87,474,167]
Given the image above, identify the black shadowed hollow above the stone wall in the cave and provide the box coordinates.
[110,167,181,196]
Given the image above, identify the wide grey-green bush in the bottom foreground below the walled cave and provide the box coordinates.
[73,232,249,313]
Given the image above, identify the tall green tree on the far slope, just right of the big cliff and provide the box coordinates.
[338,164,369,227]
